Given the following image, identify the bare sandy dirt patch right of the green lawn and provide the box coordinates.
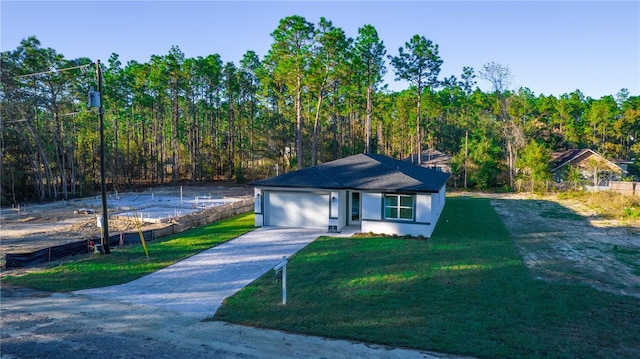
[484,195,640,298]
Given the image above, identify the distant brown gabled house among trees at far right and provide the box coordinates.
[551,148,626,186]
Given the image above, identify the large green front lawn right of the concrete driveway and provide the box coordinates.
[213,197,640,358]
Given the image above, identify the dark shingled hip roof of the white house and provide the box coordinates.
[251,154,449,193]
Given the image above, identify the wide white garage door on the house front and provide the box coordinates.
[264,192,329,229]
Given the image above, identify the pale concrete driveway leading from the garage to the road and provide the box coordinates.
[75,227,352,317]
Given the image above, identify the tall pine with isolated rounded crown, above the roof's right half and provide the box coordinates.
[389,35,442,163]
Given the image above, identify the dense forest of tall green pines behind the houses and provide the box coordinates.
[0,16,640,204]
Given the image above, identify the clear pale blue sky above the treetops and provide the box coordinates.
[0,0,640,99]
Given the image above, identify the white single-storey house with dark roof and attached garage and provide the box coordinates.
[251,154,449,237]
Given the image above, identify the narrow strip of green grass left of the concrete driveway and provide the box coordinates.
[2,213,255,292]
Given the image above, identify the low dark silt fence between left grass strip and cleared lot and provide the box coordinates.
[5,198,254,268]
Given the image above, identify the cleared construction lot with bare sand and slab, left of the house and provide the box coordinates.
[0,185,253,263]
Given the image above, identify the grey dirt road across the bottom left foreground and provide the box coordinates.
[0,287,470,359]
